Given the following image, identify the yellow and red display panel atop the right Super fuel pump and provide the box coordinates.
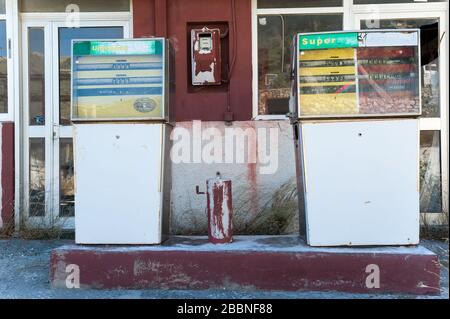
[295,30,421,118]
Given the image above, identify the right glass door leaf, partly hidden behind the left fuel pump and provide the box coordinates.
[52,21,125,228]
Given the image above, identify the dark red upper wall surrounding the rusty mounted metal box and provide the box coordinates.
[133,0,252,121]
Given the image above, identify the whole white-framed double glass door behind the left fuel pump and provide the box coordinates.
[22,21,128,229]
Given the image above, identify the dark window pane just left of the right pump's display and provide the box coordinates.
[257,8,343,115]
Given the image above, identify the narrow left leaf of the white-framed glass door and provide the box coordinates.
[22,22,53,228]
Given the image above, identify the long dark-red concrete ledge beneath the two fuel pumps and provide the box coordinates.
[50,236,440,294]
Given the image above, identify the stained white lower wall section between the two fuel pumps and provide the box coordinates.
[171,121,297,235]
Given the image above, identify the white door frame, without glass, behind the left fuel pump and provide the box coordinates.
[15,12,132,231]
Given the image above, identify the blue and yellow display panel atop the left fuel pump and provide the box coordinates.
[72,39,165,121]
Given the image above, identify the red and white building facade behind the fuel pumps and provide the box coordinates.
[0,0,449,234]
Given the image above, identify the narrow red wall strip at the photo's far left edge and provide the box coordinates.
[0,123,14,230]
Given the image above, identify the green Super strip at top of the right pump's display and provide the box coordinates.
[299,32,358,50]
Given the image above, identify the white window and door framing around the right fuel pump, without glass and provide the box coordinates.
[251,0,450,216]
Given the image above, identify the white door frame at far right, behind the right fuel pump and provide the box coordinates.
[353,3,449,222]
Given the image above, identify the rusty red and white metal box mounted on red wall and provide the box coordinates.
[191,27,222,85]
